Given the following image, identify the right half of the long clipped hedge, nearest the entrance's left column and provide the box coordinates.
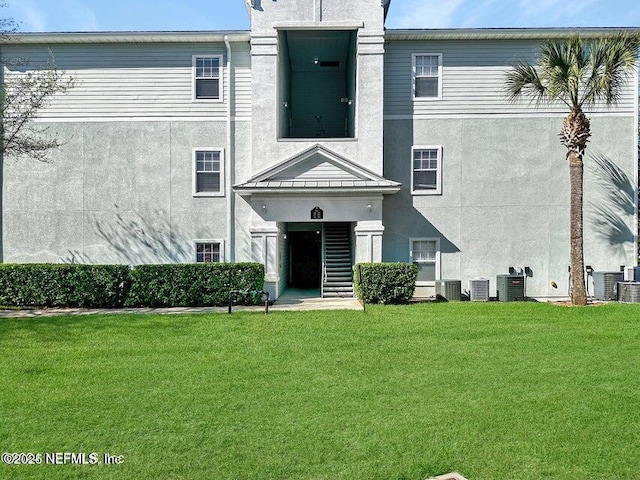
[125,263,264,307]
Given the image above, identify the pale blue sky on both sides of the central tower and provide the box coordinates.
[0,0,640,32]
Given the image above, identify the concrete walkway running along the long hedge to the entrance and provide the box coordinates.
[0,289,363,318]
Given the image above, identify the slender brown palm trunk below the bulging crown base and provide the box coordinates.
[569,150,587,305]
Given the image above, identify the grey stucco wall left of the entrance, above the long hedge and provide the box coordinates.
[3,122,227,264]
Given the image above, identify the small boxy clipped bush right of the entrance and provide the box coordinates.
[354,263,418,303]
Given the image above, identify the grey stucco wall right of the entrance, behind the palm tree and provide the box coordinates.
[383,117,635,296]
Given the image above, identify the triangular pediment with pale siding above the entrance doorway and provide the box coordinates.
[233,145,401,195]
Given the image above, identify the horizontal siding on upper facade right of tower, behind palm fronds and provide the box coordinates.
[384,40,635,116]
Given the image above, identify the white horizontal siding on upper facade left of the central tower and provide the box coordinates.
[2,42,251,120]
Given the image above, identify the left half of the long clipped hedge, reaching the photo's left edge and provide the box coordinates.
[0,263,129,308]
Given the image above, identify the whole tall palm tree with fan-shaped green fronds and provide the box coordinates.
[505,32,640,305]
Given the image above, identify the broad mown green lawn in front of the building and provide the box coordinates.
[0,303,640,480]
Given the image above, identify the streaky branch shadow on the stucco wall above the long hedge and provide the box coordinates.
[65,206,193,265]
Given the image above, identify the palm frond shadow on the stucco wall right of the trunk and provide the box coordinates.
[589,151,636,255]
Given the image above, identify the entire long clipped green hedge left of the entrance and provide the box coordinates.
[0,263,264,308]
